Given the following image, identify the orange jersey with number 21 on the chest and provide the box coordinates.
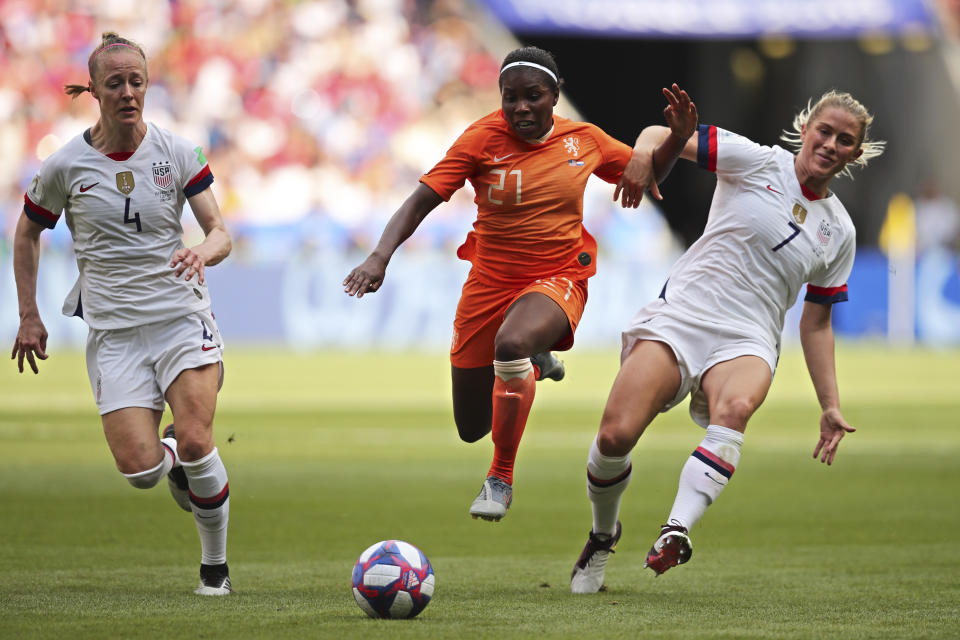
[420,110,632,287]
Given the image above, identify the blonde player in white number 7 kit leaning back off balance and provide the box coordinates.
[570,85,884,593]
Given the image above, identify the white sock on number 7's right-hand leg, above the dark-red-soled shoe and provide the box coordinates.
[667,424,743,531]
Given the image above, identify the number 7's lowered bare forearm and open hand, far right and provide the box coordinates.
[800,302,856,465]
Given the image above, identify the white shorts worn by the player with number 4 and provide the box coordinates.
[87,311,223,415]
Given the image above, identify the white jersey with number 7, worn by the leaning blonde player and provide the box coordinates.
[661,125,856,353]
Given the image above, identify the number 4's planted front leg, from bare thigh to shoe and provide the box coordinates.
[166,363,230,595]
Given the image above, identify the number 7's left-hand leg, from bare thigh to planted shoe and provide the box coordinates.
[570,340,680,593]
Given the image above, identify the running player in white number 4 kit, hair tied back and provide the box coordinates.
[12,33,231,595]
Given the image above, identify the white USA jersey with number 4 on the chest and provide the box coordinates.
[24,124,213,329]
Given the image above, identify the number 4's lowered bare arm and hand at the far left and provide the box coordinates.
[10,214,47,373]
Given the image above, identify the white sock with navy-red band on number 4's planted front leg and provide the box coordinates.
[180,447,230,564]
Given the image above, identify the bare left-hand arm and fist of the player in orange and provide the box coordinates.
[343,182,443,298]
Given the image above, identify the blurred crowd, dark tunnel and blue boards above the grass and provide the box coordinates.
[0,0,960,351]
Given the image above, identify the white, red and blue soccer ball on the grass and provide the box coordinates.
[353,540,434,618]
